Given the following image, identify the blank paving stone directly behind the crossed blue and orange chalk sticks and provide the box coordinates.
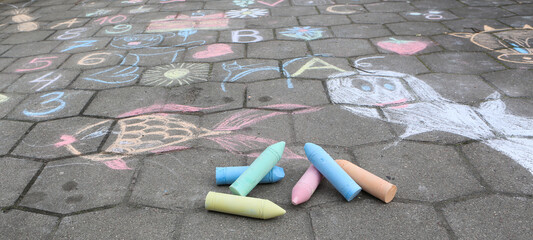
[294,106,393,146]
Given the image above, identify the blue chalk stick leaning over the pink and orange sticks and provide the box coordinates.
[304,143,361,201]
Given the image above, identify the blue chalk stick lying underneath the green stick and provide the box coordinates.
[216,166,285,185]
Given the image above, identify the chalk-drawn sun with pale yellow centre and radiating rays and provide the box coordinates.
[141,63,209,87]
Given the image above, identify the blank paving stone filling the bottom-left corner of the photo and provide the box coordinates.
[0,210,58,239]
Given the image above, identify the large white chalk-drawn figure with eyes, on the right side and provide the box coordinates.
[327,57,533,173]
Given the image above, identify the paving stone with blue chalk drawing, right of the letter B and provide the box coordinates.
[276,26,333,41]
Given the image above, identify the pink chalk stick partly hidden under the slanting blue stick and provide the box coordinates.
[291,164,323,205]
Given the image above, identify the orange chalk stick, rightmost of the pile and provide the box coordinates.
[335,159,397,203]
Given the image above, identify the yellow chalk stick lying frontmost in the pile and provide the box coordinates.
[205,192,285,219]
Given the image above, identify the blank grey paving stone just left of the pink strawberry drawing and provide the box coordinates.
[309,38,376,57]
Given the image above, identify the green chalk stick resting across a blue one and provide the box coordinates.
[229,142,285,196]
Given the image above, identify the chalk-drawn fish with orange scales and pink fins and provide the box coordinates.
[54,104,322,170]
